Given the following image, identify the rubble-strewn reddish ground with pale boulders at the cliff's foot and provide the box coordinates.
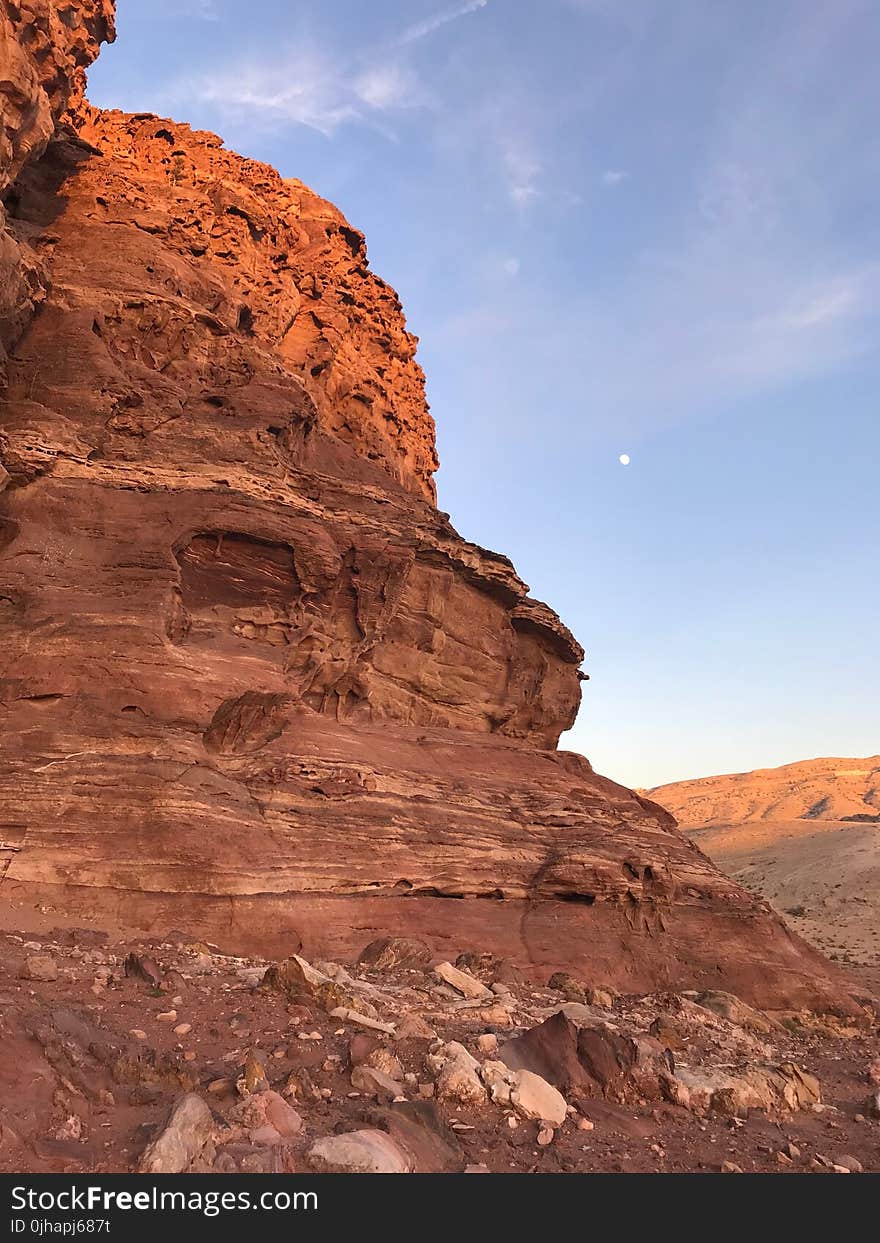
[0,912,880,1173]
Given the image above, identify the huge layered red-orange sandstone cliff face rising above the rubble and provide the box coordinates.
[0,4,855,1007]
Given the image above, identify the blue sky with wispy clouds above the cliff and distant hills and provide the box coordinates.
[89,0,880,786]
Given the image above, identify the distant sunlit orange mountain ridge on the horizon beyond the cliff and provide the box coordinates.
[645,756,880,825]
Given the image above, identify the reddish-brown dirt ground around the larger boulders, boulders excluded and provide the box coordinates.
[0,894,880,1173]
